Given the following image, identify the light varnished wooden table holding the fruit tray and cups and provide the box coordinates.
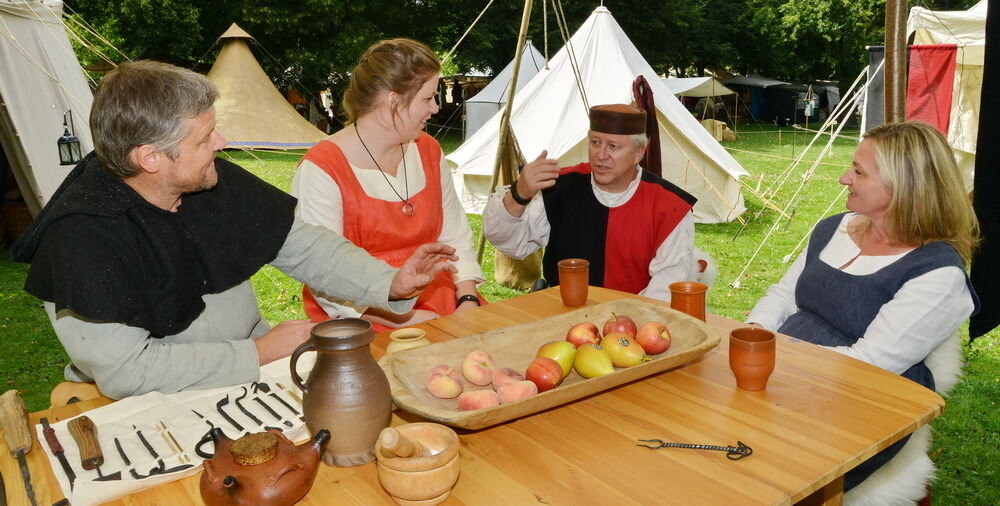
[0,287,944,505]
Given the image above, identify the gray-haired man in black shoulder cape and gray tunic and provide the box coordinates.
[13,61,456,398]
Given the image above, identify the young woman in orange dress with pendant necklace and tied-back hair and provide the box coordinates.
[292,39,484,331]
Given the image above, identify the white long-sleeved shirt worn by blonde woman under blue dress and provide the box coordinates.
[746,213,974,374]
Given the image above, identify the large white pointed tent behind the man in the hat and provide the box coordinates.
[448,7,746,223]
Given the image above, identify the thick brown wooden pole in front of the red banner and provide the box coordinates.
[885,0,906,123]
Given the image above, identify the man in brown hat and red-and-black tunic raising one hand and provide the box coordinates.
[483,104,696,300]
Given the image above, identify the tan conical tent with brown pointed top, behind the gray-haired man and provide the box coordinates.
[208,23,326,149]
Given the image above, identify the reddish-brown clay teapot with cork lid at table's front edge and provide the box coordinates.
[201,427,330,506]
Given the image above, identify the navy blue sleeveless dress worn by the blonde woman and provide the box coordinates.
[778,213,979,491]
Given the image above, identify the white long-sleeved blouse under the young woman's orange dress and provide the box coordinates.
[290,141,486,318]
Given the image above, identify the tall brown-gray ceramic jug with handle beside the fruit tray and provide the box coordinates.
[291,318,392,467]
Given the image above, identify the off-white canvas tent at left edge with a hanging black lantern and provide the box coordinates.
[0,0,93,216]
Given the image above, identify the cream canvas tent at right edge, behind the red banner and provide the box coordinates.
[906,0,987,189]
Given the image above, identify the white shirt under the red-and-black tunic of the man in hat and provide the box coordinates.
[483,167,694,302]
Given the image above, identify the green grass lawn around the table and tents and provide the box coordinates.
[0,126,1000,505]
